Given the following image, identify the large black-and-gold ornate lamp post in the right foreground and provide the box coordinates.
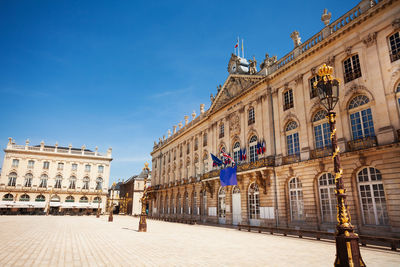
[314,64,365,267]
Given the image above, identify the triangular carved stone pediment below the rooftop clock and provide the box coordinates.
[210,75,264,111]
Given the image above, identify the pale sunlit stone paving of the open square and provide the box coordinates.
[0,216,400,266]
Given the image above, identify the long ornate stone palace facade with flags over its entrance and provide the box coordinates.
[149,0,400,239]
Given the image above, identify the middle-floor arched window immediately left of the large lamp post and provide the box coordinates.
[312,110,331,148]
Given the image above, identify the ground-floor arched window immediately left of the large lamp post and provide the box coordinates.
[318,173,337,223]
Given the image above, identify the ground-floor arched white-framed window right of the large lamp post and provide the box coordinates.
[357,167,389,225]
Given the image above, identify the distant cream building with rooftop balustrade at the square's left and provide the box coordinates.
[0,138,112,214]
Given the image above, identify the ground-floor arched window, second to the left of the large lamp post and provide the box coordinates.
[289,178,304,221]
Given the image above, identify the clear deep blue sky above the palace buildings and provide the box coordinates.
[0,0,358,183]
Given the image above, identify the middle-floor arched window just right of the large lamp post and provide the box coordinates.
[349,95,375,140]
